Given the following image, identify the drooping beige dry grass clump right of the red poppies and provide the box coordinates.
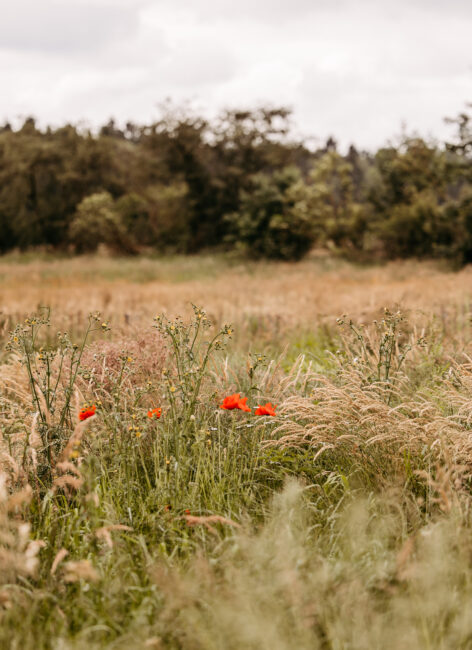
[270,366,472,489]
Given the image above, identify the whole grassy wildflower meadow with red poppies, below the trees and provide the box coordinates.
[0,254,472,650]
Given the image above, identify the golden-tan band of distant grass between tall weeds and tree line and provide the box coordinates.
[0,257,472,329]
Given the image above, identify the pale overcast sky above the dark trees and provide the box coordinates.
[0,0,472,148]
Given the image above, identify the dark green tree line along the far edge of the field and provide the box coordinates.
[0,107,472,265]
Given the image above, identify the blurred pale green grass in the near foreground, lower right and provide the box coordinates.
[152,484,472,650]
